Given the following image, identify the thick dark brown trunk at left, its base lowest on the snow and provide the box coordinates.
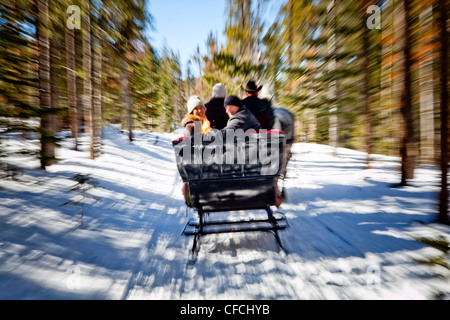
[36,0,55,170]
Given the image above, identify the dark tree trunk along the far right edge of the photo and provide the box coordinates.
[438,0,449,224]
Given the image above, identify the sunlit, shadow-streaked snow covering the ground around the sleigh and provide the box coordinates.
[0,126,450,300]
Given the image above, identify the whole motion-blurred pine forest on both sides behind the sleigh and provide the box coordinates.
[0,0,449,223]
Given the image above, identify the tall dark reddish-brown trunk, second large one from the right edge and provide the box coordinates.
[400,0,417,186]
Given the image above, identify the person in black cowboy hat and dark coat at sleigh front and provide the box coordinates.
[242,80,275,130]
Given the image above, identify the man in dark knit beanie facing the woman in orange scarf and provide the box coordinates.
[223,95,262,131]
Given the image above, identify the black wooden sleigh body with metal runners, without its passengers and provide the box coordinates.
[172,130,289,253]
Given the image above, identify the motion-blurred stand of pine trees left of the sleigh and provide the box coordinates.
[0,0,181,165]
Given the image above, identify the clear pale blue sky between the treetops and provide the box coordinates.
[147,0,226,74]
